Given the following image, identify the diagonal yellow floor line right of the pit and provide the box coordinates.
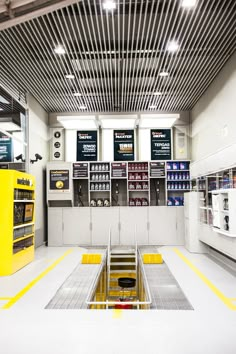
[174,248,236,311]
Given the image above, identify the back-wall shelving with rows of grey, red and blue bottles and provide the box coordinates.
[48,160,191,207]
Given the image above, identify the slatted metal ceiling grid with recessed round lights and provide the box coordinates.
[0,0,236,112]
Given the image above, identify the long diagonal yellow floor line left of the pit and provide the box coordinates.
[2,249,73,310]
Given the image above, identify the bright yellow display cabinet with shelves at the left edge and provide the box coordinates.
[0,170,35,276]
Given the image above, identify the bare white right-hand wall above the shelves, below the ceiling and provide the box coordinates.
[191,53,236,176]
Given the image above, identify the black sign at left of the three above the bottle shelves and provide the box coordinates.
[77,130,97,161]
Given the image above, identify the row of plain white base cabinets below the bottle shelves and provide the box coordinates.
[48,206,184,246]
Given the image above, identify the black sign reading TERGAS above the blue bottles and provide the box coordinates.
[151,129,171,160]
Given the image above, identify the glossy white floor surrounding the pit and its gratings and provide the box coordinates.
[0,247,236,354]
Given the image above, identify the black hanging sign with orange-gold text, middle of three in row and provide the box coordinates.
[114,130,134,161]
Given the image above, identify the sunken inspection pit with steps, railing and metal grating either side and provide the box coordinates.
[46,247,193,310]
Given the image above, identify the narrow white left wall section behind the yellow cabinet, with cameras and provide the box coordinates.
[27,95,49,247]
